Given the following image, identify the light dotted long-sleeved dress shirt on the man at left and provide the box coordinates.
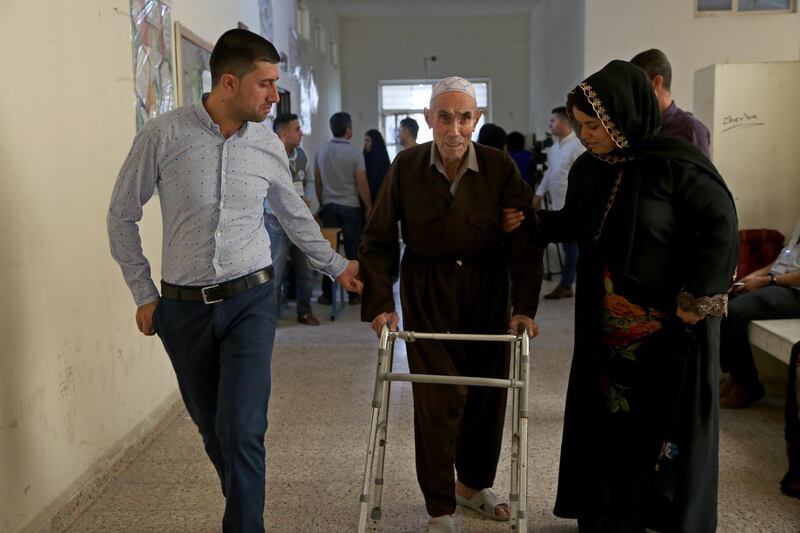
[107,99,347,305]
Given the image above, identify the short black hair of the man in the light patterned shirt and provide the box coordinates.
[210,28,281,86]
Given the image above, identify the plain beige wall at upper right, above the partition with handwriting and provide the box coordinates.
[585,0,800,110]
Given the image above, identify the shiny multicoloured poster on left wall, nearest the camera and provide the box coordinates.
[131,0,175,130]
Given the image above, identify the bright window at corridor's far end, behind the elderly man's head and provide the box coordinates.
[378,78,491,159]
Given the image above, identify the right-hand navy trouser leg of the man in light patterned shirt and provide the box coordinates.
[216,282,277,533]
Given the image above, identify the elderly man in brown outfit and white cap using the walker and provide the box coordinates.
[359,77,542,532]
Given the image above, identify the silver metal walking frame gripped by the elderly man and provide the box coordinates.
[358,324,530,533]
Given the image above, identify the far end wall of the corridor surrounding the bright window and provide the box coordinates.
[340,15,530,139]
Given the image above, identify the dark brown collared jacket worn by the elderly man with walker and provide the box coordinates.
[359,143,542,331]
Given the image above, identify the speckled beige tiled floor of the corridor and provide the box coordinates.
[69,284,800,533]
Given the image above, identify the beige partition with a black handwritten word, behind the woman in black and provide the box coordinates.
[695,61,800,238]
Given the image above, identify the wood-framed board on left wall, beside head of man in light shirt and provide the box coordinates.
[175,22,214,105]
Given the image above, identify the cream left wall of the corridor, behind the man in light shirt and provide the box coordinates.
[0,0,339,532]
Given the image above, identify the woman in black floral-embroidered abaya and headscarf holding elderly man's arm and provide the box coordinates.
[510,61,738,533]
